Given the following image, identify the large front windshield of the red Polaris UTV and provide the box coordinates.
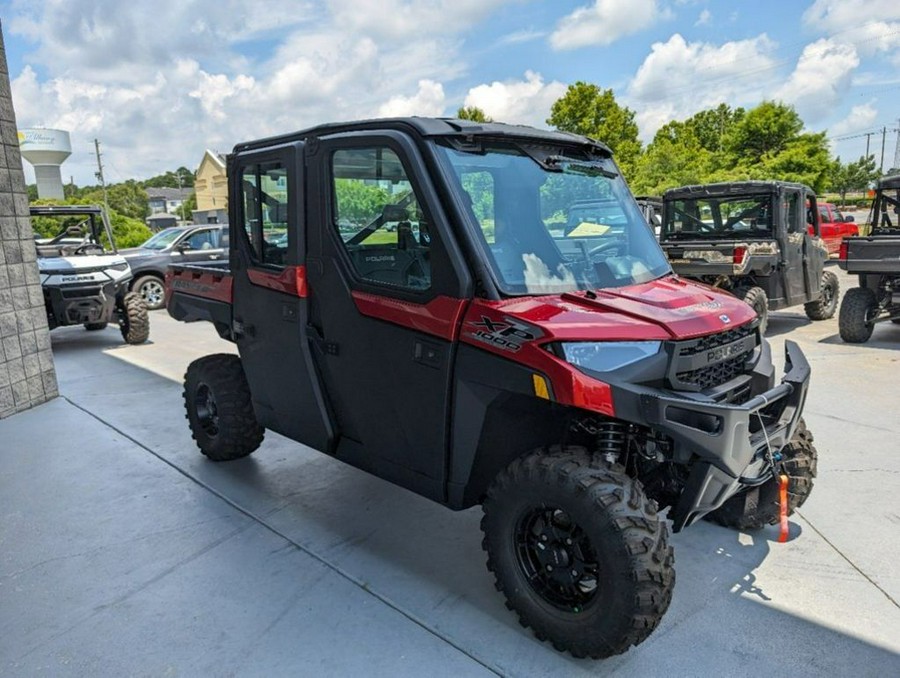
[432,143,671,295]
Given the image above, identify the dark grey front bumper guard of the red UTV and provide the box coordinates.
[614,341,810,532]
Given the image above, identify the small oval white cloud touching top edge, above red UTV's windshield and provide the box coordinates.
[550,0,671,50]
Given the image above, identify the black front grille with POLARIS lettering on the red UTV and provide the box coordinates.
[669,323,759,400]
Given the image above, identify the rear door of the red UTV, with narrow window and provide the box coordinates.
[228,143,333,451]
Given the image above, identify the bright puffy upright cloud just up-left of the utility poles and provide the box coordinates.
[773,38,859,124]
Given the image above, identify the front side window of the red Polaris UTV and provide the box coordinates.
[332,147,431,291]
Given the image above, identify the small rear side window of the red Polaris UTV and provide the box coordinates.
[241,162,289,267]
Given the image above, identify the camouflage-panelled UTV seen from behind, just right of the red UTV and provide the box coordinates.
[659,181,838,333]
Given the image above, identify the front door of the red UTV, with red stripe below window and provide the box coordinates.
[307,131,470,501]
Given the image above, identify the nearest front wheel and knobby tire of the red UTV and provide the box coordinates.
[481,447,675,659]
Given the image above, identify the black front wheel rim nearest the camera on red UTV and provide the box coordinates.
[515,506,600,613]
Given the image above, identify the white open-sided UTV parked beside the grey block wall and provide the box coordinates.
[31,205,150,344]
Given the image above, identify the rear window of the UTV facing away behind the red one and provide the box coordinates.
[660,195,773,240]
